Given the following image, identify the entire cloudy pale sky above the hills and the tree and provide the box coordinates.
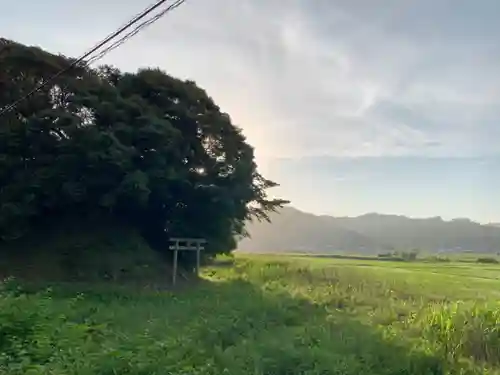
[0,0,500,222]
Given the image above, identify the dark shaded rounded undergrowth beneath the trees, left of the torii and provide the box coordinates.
[0,217,167,283]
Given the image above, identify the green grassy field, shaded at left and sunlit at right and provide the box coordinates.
[0,255,500,375]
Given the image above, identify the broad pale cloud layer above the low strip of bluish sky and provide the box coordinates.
[0,0,500,162]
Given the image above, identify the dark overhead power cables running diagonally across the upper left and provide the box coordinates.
[0,0,186,116]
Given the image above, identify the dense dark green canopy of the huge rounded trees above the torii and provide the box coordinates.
[0,39,285,262]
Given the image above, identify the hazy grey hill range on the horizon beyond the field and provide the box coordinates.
[239,207,500,254]
